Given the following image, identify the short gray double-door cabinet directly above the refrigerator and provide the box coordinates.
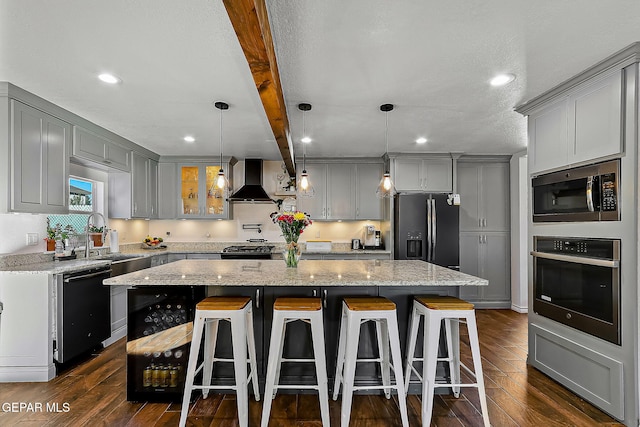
[393,156,453,192]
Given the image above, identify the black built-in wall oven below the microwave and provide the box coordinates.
[531,236,621,345]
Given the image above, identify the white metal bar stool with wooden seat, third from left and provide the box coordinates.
[333,297,409,427]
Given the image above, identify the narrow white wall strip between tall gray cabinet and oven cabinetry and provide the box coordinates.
[510,151,529,313]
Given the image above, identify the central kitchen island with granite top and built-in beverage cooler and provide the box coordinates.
[104,260,488,401]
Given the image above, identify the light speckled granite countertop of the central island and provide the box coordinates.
[104,259,488,286]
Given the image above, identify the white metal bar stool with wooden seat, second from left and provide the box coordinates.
[261,298,329,427]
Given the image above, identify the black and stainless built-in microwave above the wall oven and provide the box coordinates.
[531,159,620,222]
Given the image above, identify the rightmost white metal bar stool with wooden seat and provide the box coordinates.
[405,296,490,426]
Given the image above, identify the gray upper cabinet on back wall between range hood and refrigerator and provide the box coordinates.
[297,159,383,221]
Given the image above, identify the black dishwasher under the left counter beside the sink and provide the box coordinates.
[54,266,111,363]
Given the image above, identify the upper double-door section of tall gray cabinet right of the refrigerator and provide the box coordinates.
[458,160,510,232]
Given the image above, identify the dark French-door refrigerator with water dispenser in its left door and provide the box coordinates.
[394,194,460,270]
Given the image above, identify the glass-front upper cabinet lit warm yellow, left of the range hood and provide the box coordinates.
[178,159,235,219]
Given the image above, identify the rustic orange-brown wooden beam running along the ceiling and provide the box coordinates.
[223,0,296,176]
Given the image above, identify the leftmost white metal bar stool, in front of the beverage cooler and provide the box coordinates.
[179,297,260,427]
